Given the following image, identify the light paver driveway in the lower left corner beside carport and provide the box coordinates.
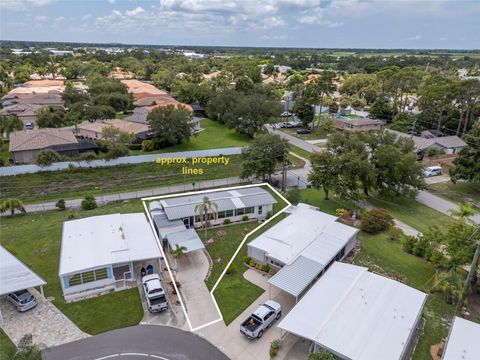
[0,289,89,347]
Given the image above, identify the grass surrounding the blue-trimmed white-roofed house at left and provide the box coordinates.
[0,201,144,334]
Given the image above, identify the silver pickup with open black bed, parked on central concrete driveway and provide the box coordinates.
[240,300,282,339]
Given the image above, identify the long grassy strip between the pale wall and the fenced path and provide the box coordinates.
[0,155,241,203]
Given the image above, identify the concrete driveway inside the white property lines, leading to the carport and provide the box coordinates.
[173,251,220,329]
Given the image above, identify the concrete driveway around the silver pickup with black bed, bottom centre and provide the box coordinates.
[197,270,306,360]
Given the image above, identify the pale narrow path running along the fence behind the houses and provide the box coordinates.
[15,177,250,213]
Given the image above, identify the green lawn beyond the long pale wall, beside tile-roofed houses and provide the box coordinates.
[130,119,251,155]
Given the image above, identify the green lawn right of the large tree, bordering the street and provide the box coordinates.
[368,196,453,232]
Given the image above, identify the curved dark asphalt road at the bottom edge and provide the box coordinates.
[42,325,228,360]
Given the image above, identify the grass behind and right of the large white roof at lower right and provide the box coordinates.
[354,232,455,360]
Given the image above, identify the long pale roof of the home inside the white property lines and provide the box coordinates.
[158,187,276,220]
